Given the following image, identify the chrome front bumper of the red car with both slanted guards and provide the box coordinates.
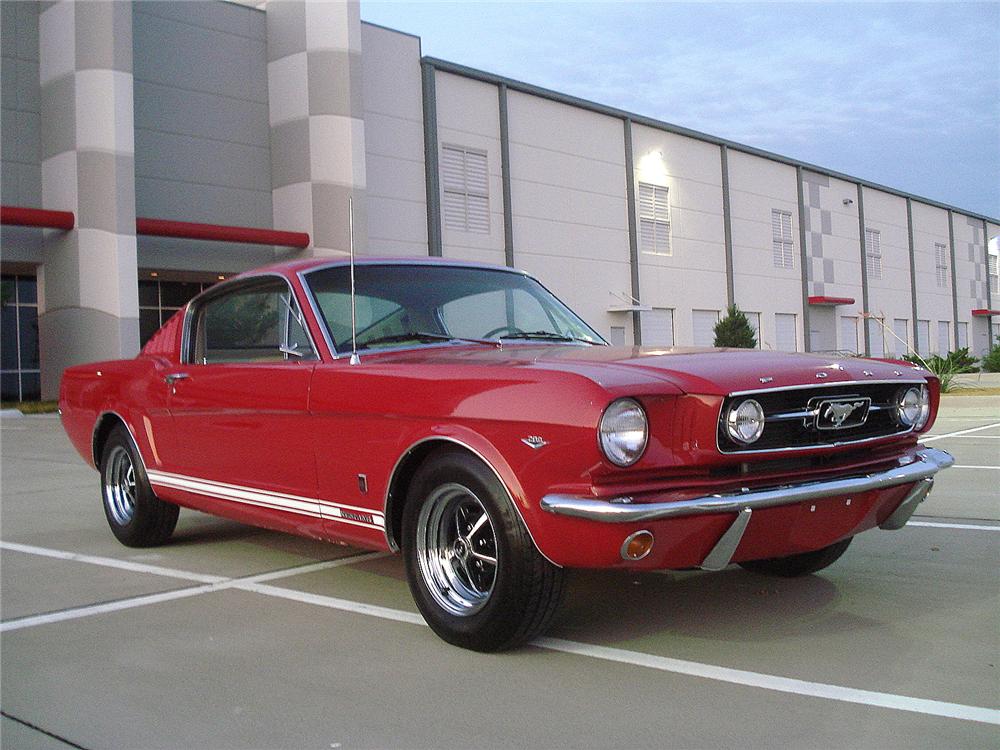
[541,448,955,570]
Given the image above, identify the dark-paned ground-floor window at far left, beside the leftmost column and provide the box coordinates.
[0,274,42,401]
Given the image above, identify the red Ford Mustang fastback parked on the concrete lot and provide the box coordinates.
[59,260,952,651]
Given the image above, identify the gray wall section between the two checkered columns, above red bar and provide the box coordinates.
[133,2,272,235]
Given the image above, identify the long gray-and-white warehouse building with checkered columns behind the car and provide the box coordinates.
[0,0,1000,400]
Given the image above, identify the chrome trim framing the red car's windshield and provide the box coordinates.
[296,258,610,360]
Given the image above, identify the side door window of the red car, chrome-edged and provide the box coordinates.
[194,282,316,364]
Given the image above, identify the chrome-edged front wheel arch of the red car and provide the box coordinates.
[384,435,562,567]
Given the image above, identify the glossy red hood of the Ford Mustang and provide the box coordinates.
[372,344,928,395]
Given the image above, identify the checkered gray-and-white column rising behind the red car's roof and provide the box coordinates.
[267,0,368,256]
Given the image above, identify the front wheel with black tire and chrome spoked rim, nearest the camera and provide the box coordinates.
[402,451,563,651]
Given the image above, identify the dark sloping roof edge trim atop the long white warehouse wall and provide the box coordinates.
[421,57,1000,224]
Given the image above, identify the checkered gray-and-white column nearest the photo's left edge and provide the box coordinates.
[38,0,139,398]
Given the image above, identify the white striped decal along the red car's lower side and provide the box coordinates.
[146,469,385,530]
